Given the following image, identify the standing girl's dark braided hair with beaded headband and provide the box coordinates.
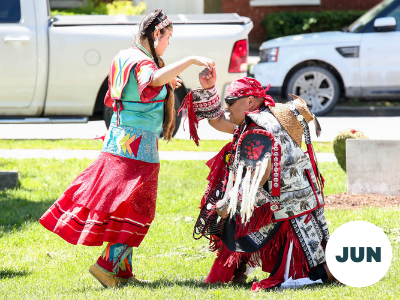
[138,8,172,68]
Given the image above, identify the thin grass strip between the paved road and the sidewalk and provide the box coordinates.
[0,139,333,153]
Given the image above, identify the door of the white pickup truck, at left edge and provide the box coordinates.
[0,0,38,108]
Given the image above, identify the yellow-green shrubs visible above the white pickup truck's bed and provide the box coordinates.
[51,0,146,17]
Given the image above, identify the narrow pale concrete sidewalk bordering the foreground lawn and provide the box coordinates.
[0,149,336,162]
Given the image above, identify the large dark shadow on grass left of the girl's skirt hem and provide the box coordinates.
[0,190,57,237]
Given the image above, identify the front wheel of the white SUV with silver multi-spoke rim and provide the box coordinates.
[287,66,340,116]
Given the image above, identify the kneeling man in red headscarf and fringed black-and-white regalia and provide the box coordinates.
[183,69,334,291]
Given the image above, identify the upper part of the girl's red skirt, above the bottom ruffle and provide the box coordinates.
[64,152,160,218]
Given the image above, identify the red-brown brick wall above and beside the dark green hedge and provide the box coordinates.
[222,0,382,48]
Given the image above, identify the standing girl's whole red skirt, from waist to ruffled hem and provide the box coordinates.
[40,152,160,247]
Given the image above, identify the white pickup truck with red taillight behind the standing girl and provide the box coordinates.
[0,0,253,134]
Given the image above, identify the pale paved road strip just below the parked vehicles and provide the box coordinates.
[0,117,400,143]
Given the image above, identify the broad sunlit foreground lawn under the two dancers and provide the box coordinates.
[0,158,400,300]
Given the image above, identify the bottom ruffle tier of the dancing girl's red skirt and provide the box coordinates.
[39,195,152,247]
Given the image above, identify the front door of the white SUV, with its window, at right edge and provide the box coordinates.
[360,1,400,98]
